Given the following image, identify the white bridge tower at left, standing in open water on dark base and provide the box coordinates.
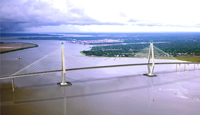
[57,42,72,86]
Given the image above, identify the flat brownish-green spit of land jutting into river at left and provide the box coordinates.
[0,42,38,54]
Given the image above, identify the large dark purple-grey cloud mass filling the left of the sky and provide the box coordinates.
[0,0,124,32]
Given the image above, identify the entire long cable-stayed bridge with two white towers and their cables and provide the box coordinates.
[0,42,199,90]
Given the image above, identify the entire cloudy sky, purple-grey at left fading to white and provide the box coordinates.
[0,0,200,33]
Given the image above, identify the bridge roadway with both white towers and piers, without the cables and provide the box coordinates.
[0,42,200,91]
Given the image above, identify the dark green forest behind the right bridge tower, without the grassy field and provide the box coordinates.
[82,40,200,57]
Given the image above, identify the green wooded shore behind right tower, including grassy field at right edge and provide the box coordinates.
[82,41,200,62]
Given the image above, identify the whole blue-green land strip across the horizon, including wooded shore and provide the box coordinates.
[1,32,200,62]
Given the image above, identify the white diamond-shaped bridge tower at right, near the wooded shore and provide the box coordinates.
[143,41,157,77]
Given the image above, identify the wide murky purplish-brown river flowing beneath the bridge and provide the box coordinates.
[0,40,200,115]
